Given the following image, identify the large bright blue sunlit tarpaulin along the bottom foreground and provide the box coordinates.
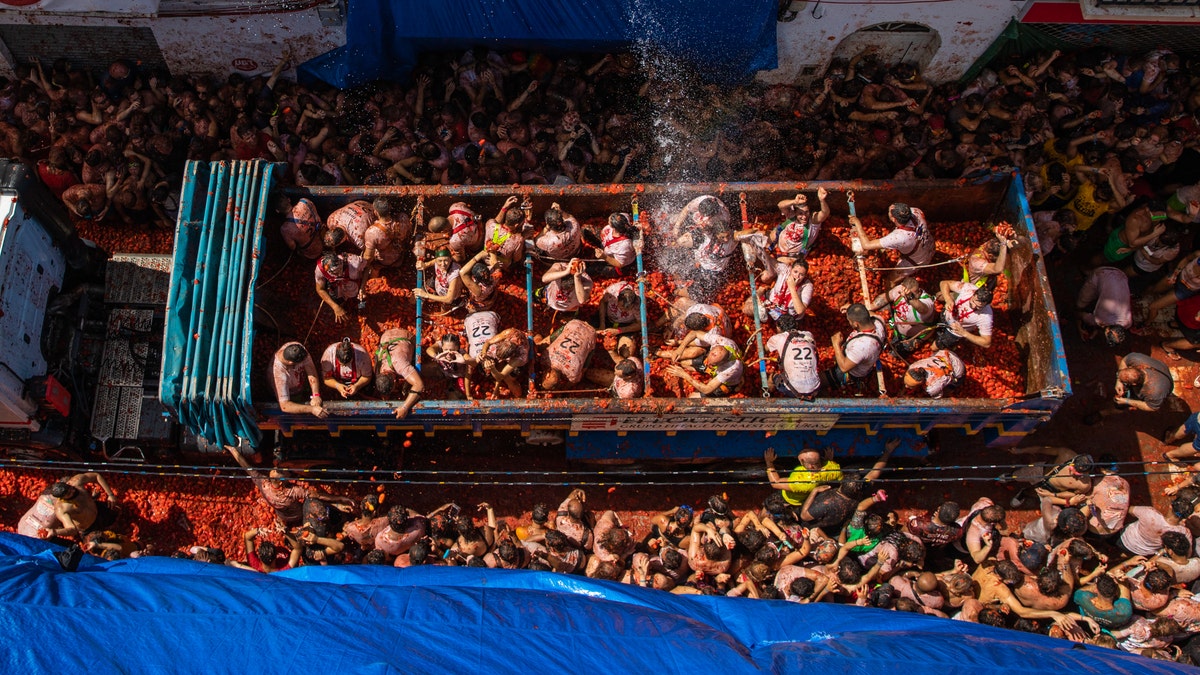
[0,533,1192,675]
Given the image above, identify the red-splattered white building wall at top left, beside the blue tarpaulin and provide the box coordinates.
[0,10,346,76]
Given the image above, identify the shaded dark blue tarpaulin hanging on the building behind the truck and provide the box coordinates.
[300,0,779,88]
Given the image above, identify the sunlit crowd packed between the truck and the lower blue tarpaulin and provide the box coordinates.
[17,441,1200,663]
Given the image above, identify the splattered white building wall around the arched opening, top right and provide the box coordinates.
[760,0,1025,83]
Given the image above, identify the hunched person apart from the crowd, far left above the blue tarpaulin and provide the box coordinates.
[17,472,118,539]
